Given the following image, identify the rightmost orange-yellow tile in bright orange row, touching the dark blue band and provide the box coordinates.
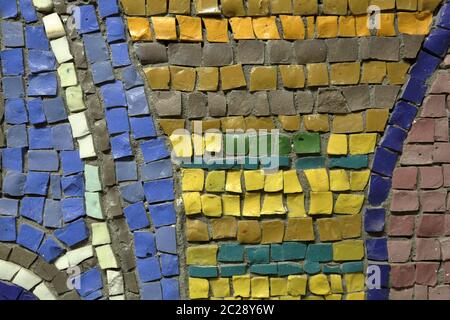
[397,11,433,35]
